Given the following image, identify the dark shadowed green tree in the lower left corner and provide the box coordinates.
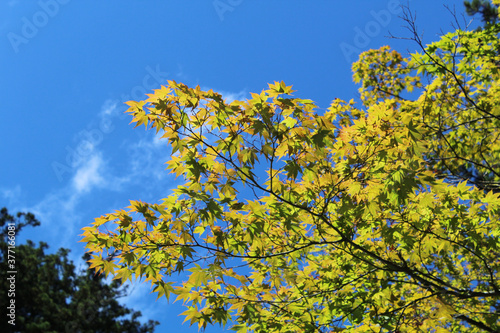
[0,208,158,333]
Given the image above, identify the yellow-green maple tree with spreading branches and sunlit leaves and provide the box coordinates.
[82,4,500,333]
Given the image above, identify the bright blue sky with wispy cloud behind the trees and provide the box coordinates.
[0,0,478,333]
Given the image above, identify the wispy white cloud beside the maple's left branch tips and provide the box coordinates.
[26,89,247,237]
